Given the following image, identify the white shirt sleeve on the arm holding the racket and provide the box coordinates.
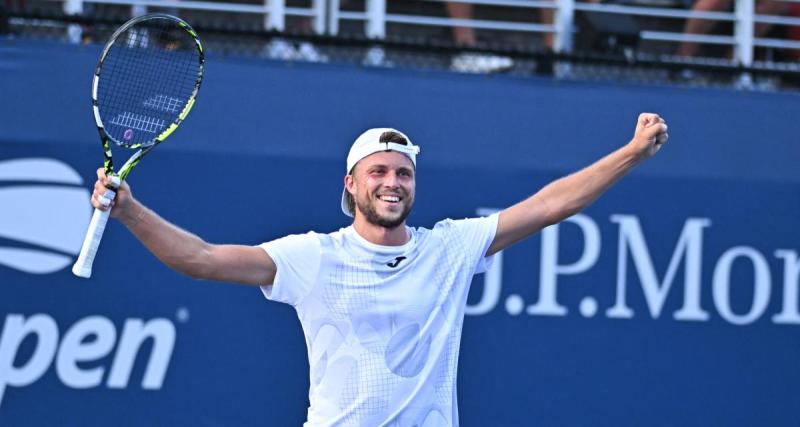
[259,232,322,306]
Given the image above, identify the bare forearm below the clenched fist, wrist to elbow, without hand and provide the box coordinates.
[532,144,644,224]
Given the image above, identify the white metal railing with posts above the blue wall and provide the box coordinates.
[40,0,800,67]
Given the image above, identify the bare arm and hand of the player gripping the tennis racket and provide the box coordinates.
[92,168,276,285]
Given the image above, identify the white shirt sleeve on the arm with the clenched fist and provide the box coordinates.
[436,213,499,274]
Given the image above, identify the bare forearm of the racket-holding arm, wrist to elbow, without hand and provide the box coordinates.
[118,200,211,278]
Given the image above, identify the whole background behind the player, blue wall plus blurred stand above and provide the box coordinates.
[0,0,800,426]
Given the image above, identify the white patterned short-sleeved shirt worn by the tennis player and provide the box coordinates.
[261,215,497,426]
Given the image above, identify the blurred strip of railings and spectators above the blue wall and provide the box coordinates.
[0,0,800,86]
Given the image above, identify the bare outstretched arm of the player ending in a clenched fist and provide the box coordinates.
[486,113,668,256]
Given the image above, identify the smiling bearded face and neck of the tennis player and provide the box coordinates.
[344,151,416,246]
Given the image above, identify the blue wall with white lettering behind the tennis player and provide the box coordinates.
[0,40,800,426]
